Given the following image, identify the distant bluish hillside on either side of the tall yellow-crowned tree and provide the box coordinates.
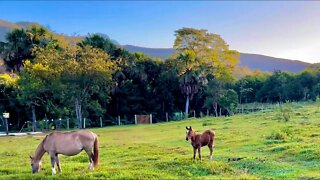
[123,45,311,72]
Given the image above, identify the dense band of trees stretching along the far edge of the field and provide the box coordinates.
[0,26,320,130]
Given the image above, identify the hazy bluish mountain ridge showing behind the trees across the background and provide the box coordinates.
[0,20,312,72]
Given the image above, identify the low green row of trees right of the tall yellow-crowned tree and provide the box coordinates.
[234,69,320,103]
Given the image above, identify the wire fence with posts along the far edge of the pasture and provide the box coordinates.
[0,103,296,134]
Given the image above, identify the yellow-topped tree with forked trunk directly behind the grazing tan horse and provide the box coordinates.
[61,46,116,128]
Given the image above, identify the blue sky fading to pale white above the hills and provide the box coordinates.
[0,1,320,62]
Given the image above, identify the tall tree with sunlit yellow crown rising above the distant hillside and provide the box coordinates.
[174,28,239,116]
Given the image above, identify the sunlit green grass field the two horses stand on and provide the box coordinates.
[0,103,320,179]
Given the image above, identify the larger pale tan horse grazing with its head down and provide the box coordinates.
[30,131,99,174]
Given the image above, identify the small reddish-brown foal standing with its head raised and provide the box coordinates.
[186,126,215,160]
